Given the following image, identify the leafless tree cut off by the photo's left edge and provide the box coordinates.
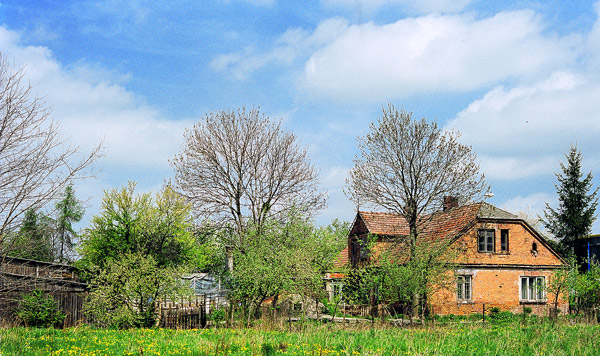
[0,54,101,252]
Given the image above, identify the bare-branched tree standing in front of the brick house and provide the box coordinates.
[347,105,489,316]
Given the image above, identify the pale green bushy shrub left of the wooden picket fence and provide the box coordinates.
[86,253,190,328]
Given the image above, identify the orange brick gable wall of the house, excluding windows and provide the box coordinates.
[429,221,568,315]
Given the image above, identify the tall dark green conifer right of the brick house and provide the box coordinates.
[542,146,598,254]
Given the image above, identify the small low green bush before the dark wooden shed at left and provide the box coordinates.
[16,289,65,328]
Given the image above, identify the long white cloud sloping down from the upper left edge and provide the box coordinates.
[0,27,191,170]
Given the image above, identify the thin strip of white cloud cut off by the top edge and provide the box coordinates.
[321,0,472,14]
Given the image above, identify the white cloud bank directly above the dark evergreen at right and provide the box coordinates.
[449,72,600,180]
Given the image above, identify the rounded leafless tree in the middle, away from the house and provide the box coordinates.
[171,108,325,243]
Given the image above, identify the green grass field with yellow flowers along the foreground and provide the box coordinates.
[0,323,600,356]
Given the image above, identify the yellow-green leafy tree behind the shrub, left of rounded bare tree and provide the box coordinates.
[81,183,196,268]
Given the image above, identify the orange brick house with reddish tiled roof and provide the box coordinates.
[336,200,568,315]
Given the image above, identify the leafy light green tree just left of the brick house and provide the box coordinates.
[226,213,347,321]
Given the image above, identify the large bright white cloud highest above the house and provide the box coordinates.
[301,11,578,102]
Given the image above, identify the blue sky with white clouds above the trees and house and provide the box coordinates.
[0,0,600,233]
